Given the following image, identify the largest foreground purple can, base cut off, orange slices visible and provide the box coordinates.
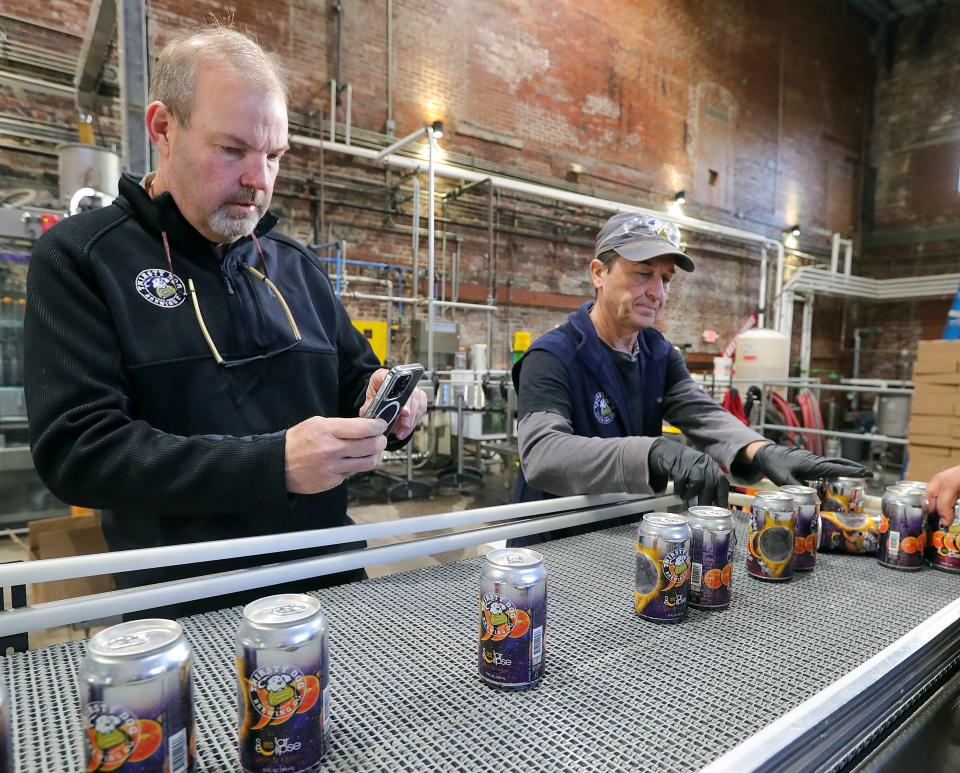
[79,619,196,773]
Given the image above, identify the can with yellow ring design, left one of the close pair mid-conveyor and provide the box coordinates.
[633,513,691,623]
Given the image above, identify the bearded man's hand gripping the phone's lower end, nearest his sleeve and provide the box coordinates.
[284,416,387,494]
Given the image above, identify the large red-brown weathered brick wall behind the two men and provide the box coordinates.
[0,0,875,365]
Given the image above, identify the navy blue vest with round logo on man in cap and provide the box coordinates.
[512,301,672,502]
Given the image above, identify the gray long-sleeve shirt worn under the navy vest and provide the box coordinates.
[518,350,764,496]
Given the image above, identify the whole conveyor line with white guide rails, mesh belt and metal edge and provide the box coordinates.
[0,494,960,773]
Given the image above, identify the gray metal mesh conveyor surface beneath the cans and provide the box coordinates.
[2,512,960,773]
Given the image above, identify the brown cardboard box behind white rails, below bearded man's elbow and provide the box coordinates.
[27,515,114,604]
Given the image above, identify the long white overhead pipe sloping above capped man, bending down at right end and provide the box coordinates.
[290,134,784,326]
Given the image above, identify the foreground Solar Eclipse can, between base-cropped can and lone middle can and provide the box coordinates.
[235,593,330,773]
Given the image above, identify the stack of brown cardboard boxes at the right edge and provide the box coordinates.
[907,341,960,480]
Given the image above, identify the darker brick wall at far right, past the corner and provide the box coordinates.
[858,2,960,377]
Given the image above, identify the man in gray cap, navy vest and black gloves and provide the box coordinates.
[513,212,870,532]
